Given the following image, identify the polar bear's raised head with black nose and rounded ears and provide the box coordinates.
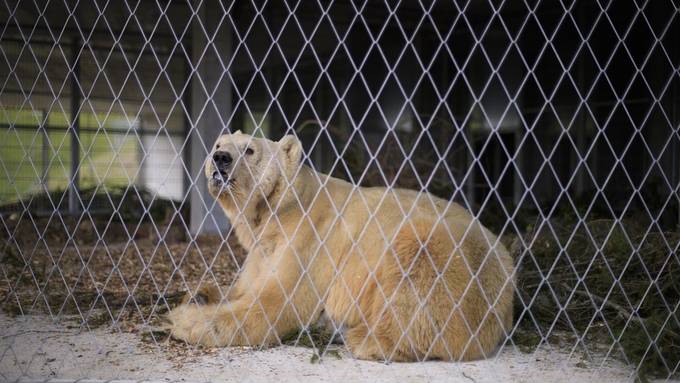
[205,131,302,206]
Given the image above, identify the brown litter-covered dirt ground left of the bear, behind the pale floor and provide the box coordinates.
[0,216,245,328]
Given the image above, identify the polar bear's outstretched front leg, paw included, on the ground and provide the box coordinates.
[168,248,320,346]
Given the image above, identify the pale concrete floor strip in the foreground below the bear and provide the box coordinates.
[0,314,644,383]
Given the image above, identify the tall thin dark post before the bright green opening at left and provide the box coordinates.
[68,37,82,215]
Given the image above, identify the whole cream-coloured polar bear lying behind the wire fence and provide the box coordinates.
[167,131,515,362]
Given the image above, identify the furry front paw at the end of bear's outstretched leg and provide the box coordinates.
[167,304,224,346]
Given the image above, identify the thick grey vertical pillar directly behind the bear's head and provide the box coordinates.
[189,0,231,235]
